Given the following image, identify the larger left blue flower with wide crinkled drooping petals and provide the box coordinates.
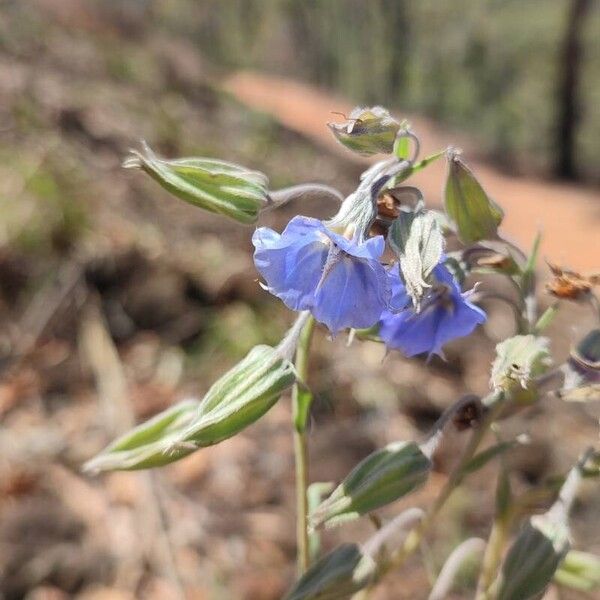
[252,216,390,333]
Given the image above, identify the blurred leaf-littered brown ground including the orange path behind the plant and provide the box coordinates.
[0,0,600,600]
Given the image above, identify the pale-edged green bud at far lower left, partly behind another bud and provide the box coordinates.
[83,400,200,473]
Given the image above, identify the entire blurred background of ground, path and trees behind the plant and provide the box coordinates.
[0,0,600,600]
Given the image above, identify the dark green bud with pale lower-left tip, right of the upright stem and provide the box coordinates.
[310,442,432,528]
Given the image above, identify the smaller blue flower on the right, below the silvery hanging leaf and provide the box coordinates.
[379,263,486,356]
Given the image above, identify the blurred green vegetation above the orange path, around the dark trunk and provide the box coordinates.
[154,0,600,179]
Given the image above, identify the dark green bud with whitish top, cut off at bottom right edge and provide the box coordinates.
[497,515,569,600]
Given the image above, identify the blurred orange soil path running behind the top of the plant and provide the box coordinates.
[222,71,600,271]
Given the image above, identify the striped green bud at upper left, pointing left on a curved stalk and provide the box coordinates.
[123,143,268,224]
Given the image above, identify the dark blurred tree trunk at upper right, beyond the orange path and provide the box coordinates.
[555,0,592,179]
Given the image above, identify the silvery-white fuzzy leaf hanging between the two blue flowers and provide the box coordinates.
[388,210,444,307]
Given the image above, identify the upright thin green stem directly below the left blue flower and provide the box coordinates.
[292,317,315,575]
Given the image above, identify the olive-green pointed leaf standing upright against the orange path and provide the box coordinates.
[444,151,504,244]
